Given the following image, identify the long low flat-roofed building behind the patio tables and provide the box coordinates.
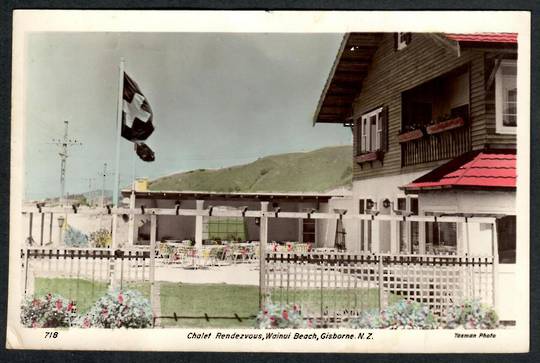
[122,187,350,252]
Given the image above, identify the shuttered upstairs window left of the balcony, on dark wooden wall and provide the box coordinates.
[359,107,386,154]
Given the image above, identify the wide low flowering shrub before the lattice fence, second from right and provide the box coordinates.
[348,300,438,329]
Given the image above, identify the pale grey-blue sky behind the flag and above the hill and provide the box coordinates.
[24,32,352,199]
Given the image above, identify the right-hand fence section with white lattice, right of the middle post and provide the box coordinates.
[264,252,495,326]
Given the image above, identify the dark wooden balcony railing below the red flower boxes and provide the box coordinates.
[401,125,471,166]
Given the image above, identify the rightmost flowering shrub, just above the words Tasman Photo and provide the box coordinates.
[446,300,499,329]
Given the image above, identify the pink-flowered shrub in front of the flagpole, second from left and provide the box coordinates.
[79,290,153,328]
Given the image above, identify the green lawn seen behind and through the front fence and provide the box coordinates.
[35,278,399,328]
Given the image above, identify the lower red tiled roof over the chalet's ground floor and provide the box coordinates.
[402,151,516,191]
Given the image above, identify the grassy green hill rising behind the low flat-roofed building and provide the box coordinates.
[149,146,352,192]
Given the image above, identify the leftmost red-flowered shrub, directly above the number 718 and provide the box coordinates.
[21,294,77,328]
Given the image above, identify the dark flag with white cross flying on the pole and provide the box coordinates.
[122,73,155,161]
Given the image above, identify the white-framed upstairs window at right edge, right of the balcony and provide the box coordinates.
[495,60,517,134]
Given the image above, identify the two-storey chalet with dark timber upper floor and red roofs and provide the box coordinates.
[314,33,517,264]
